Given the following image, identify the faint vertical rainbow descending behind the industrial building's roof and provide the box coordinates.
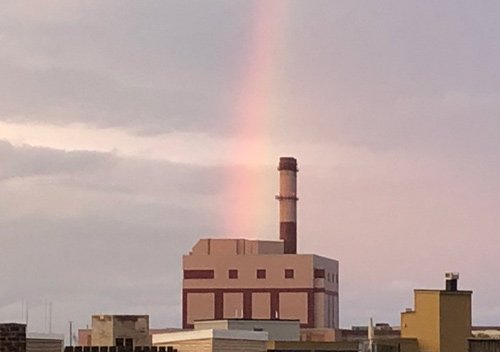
[223,0,289,237]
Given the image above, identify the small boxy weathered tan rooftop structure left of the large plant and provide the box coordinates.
[90,315,151,347]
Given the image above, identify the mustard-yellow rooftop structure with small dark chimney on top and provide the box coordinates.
[401,273,472,352]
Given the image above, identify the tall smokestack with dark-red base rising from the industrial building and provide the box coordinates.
[276,157,299,254]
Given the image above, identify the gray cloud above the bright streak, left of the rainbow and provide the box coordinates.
[0,2,254,133]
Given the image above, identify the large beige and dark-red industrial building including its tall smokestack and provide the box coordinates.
[182,158,339,328]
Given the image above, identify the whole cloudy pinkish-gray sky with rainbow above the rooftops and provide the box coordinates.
[0,0,500,332]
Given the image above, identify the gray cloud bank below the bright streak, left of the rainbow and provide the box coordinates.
[0,142,228,331]
